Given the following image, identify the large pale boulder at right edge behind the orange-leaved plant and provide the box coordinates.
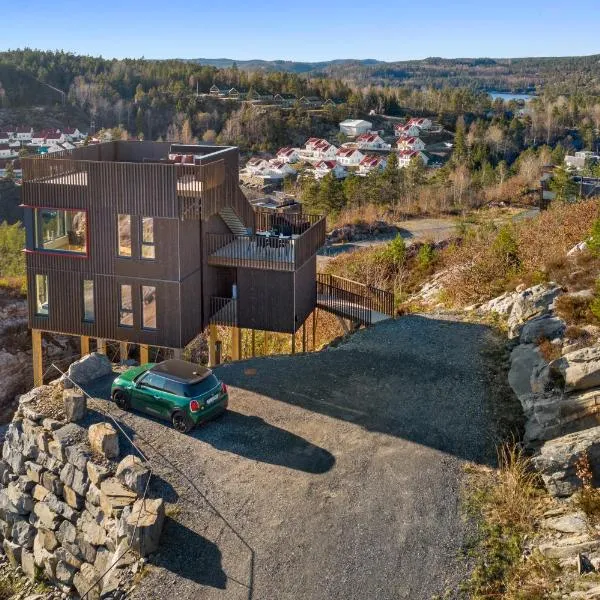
[532,426,600,497]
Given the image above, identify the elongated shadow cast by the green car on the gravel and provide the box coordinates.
[195,410,335,474]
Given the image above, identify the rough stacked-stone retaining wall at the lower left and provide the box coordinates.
[0,382,164,600]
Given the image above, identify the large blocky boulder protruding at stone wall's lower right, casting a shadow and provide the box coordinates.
[118,498,165,556]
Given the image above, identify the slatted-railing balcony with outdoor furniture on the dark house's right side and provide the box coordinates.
[205,213,325,271]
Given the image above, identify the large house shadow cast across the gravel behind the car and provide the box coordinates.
[215,315,502,465]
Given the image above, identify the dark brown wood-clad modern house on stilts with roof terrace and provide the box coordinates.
[22,141,325,385]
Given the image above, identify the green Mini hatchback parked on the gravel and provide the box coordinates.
[111,359,229,433]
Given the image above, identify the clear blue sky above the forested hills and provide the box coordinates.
[0,0,600,61]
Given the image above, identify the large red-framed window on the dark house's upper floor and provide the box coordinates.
[35,208,87,254]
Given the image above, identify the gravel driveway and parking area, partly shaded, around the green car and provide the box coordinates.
[85,316,493,600]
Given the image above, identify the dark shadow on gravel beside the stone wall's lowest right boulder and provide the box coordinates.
[152,518,227,588]
